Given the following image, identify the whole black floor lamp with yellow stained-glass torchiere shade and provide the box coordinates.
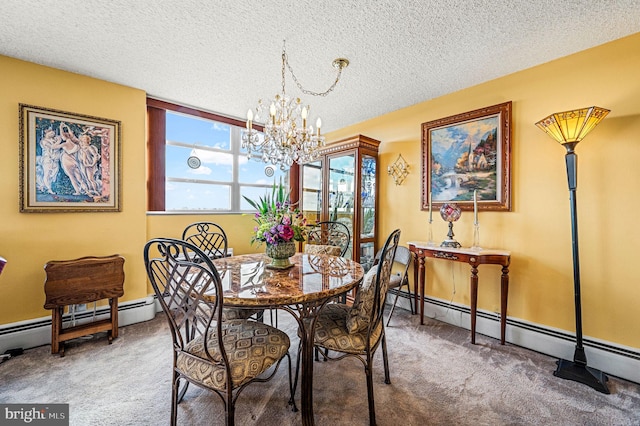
[536,106,609,394]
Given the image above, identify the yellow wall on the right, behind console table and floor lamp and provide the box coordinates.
[328,34,640,348]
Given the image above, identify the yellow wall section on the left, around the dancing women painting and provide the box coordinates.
[0,56,149,324]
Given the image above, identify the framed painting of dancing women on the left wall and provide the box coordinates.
[20,104,121,213]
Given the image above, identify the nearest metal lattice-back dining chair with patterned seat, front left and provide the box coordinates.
[144,238,297,425]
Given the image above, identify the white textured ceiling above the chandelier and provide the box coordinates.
[0,0,640,131]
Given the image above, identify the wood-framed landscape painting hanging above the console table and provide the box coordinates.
[422,102,511,211]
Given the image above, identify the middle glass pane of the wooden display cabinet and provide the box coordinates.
[328,154,356,258]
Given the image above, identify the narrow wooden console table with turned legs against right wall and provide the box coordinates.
[407,241,511,345]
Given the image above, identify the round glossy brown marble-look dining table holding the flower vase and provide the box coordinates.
[208,253,364,426]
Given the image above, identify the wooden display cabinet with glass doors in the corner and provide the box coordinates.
[291,135,380,270]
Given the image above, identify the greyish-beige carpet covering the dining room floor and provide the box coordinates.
[0,309,640,426]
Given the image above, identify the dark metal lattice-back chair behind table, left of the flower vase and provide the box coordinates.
[182,222,264,320]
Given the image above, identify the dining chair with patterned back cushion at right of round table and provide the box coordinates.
[314,229,400,425]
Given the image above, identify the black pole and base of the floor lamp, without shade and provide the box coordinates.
[553,142,609,394]
